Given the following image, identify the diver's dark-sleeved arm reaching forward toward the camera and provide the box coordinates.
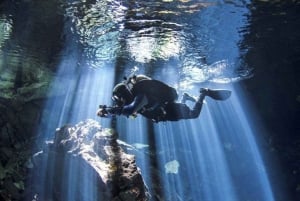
[121,94,148,116]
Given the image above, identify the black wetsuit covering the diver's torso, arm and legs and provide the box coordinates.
[120,80,204,122]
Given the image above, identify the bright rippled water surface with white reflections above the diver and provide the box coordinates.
[66,1,251,82]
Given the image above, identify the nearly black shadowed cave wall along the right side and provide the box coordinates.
[241,1,300,200]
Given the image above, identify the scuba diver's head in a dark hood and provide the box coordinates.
[112,83,133,106]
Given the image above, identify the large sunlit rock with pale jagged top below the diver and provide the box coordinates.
[31,120,149,201]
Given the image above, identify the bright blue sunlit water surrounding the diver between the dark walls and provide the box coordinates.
[21,1,284,201]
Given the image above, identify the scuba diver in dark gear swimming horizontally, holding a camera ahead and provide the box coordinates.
[97,75,231,122]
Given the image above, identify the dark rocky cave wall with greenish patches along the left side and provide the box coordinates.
[0,0,64,200]
